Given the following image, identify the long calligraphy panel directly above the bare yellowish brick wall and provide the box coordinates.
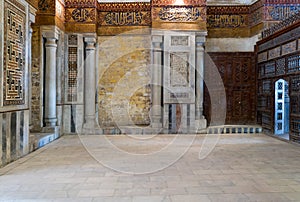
[99,11,151,26]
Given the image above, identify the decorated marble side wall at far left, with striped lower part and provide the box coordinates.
[0,0,34,166]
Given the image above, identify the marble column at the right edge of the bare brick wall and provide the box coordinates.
[151,36,163,128]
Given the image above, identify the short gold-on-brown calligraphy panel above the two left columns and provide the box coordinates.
[65,8,96,23]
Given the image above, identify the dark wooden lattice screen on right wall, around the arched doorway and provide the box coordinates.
[257,18,300,142]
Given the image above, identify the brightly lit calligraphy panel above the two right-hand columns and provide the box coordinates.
[158,7,205,22]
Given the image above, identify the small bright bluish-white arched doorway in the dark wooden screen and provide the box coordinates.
[274,79,290,140]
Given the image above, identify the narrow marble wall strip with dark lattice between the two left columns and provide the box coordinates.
[60,33,84,133]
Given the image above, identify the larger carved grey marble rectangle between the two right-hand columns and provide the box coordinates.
[170,53,189,87]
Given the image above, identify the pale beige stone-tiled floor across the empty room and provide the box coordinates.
[0,134,300,202]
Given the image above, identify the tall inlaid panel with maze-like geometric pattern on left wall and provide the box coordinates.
[3,1,26,105]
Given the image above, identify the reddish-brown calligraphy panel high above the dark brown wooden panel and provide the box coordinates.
[207,15,248,28]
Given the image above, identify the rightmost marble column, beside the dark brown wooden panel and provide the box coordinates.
[195,36,207,129]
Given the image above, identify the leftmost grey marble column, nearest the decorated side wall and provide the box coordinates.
[44,32,58,127]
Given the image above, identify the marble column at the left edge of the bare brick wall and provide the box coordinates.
[83,35,98,133]
